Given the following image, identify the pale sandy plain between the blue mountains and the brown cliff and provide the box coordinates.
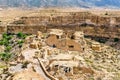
[0,8,120,24]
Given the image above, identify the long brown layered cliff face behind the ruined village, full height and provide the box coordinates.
[7,12,120,38]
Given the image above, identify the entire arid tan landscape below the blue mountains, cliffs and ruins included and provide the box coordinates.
[0,8,120,80]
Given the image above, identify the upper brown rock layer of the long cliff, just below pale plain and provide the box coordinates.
[13,12,120,25]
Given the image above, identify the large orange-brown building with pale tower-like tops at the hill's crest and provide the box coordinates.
[46,29,84,52]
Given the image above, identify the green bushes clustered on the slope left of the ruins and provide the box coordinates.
[0,32,27,62]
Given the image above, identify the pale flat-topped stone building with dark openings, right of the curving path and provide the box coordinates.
[50,61,79,75]
